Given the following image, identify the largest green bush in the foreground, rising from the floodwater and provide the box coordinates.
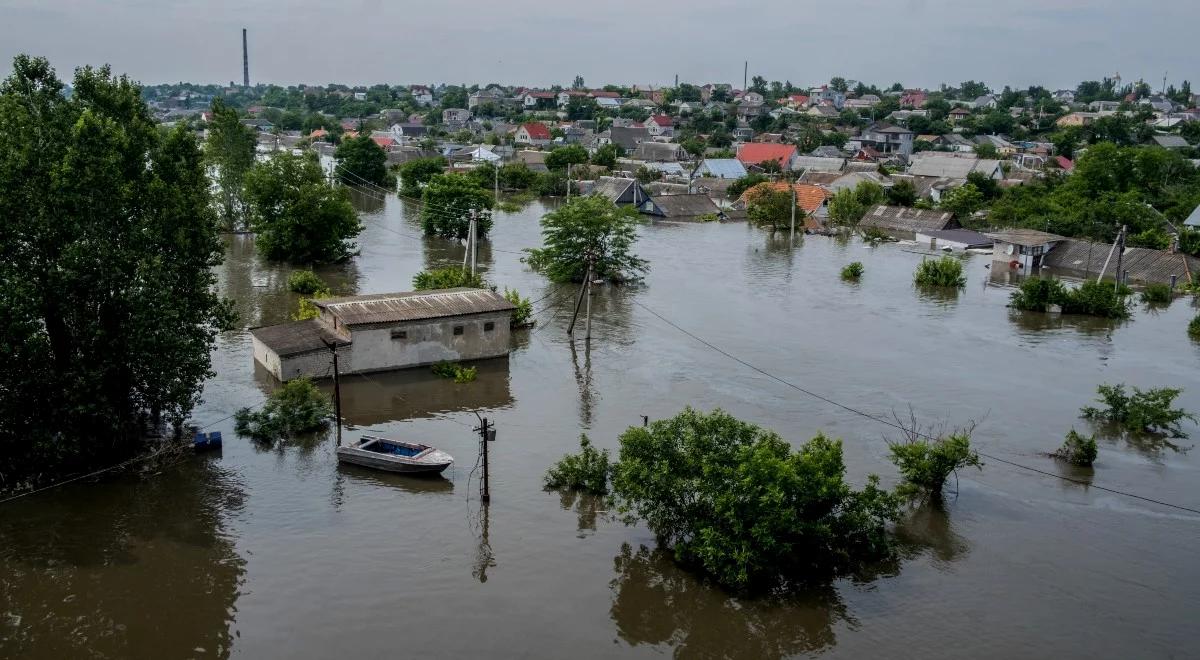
[612,408,899,589]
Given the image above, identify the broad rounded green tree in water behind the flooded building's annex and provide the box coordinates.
[246,152,362,264]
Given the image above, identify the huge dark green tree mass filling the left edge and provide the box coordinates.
[0,55,232,485]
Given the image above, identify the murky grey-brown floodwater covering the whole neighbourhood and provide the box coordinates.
[0,188,1200,659]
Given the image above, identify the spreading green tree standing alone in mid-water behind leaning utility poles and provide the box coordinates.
[526,194,648,282]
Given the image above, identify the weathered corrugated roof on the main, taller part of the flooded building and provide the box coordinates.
[313,288,516,325]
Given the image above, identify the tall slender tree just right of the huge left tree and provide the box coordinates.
[204,97,258,229]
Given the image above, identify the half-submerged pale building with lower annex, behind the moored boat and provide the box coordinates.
[250,288,515,380]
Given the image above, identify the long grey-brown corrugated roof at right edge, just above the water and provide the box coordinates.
[1042,239,1200,284]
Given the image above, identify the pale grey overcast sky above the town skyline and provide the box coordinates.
[0,0,1200,89]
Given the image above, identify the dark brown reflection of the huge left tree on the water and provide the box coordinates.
[0,458,244,660]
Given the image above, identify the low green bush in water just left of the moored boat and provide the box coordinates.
[234,377,334,442]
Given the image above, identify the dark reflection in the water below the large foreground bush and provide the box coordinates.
[610,544,848,659]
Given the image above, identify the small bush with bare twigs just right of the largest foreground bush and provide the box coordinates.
[888,431,983,499]
